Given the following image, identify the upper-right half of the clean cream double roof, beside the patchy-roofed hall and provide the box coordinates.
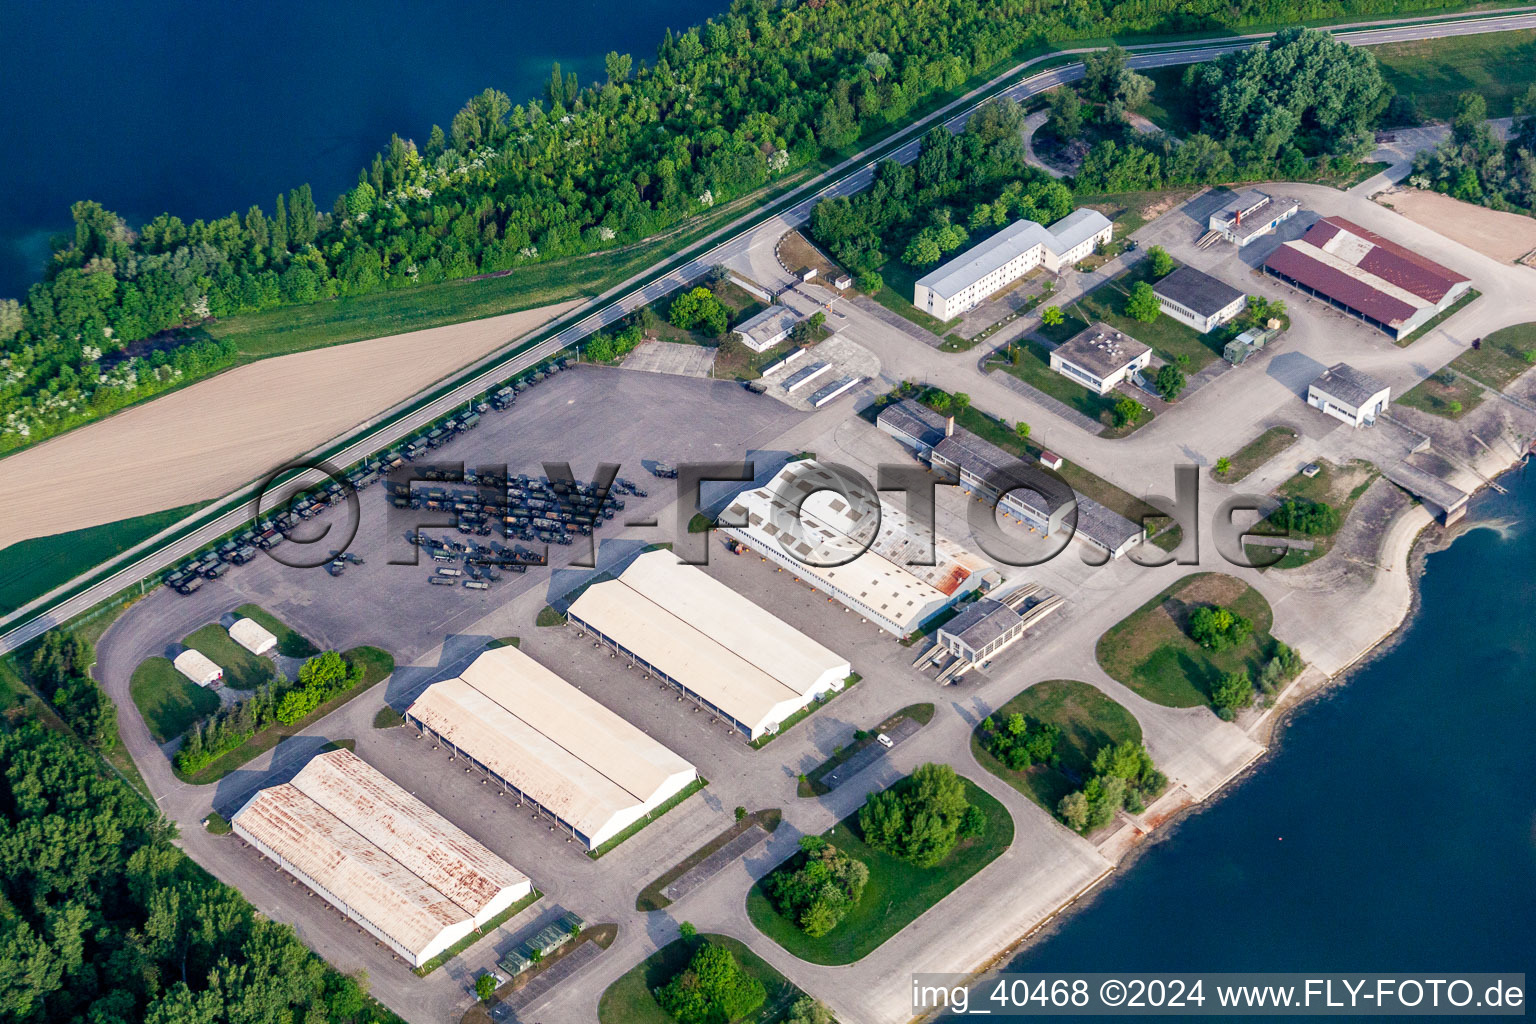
[619,548,852,706]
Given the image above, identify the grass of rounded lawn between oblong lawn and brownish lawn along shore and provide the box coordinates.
[971,679,1141,814]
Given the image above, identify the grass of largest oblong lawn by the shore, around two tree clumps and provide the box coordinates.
[746,778,1014,964]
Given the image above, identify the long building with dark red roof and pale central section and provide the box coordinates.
[1264,216,1471,338]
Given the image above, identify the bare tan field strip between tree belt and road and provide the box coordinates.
[0,299,581,548]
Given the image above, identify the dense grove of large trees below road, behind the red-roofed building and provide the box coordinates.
[1052,29,1392,193]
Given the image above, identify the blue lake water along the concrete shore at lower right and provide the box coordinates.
[1011,471,1536,972]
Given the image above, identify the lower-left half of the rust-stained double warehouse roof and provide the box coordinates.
[232,785,472,952]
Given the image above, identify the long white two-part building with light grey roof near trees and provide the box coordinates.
[912,209,1115,319]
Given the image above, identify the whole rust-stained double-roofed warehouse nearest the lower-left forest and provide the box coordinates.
[230,751,533,967]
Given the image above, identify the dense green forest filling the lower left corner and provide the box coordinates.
[0,723,398,1024]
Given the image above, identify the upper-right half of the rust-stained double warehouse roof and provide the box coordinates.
[292,749,528,921]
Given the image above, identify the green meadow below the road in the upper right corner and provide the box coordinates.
[1370,29,1536,120]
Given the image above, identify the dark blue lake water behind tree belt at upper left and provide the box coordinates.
[0,0,727,296]
